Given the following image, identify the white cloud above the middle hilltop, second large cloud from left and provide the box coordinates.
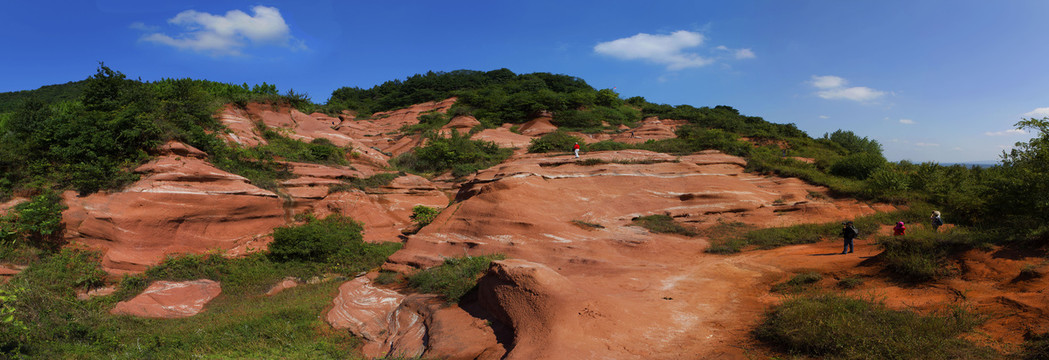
[594,30,714,70]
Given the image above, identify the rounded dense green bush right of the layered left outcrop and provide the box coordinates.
[270,214,363,262]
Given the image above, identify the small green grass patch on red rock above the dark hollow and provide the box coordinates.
[408,254,506,303]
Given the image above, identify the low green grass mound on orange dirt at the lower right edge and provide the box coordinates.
[754,294,989,359]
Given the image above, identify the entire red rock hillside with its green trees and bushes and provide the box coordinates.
[0,67,1049,359]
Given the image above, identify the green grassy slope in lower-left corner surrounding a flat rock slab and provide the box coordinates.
[0,214,400,359]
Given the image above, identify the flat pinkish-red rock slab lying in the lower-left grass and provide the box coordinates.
[109,279,222,319]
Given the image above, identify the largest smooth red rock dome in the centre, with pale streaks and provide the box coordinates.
[385,150,893,359]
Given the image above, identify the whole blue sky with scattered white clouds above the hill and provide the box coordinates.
[0,0,1049,163]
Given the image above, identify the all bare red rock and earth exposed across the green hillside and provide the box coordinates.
[43,99,1049,359]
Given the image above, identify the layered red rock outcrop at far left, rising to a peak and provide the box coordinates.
[63,143,285,273]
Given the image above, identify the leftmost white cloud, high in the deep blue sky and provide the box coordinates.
[138,5,305,56]
